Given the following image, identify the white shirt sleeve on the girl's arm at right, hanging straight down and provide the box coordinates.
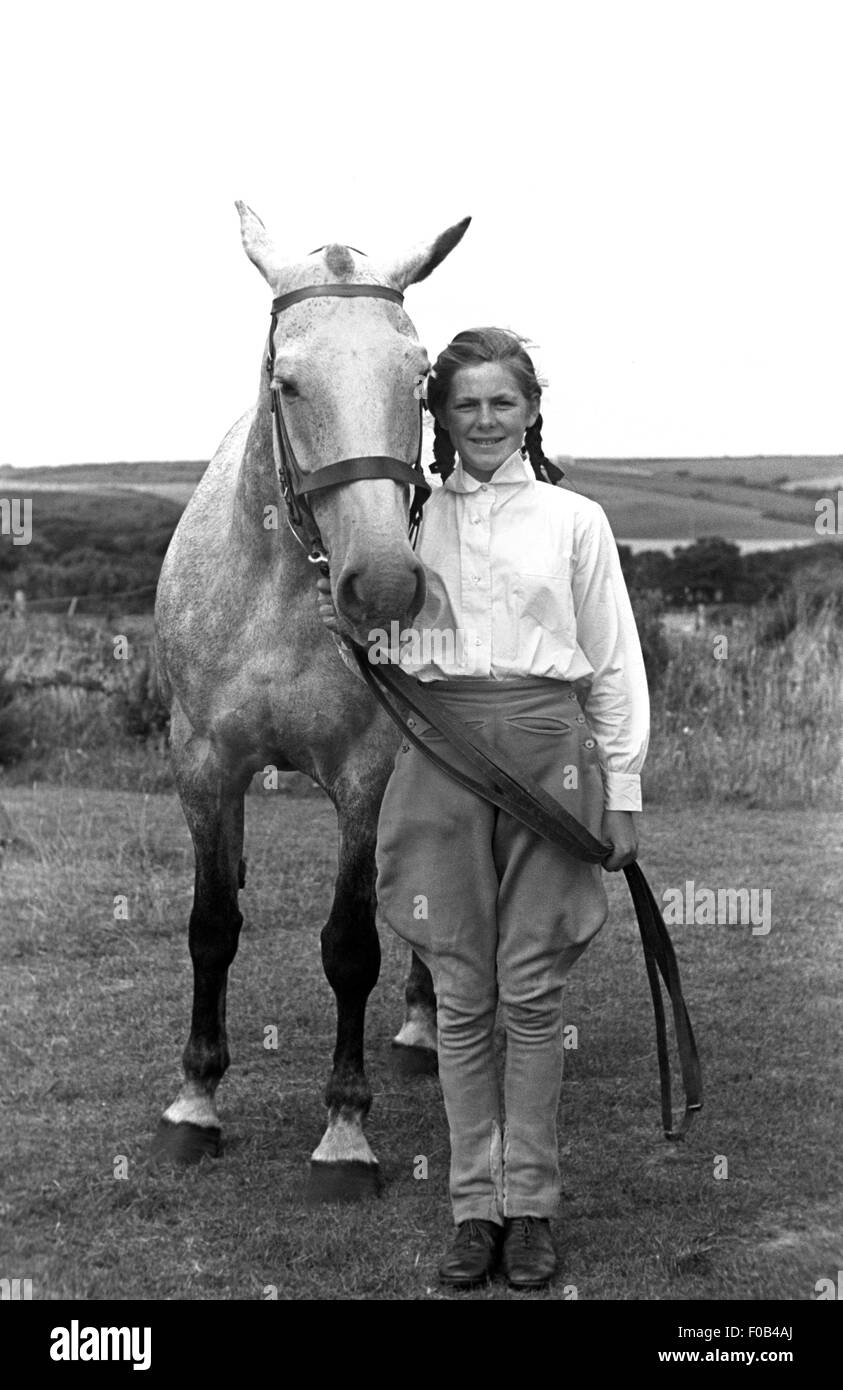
[572,503,650,810]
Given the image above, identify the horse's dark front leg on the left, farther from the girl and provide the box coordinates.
[153,706,245,1163]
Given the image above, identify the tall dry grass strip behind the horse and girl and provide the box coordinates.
[0,609,843,809]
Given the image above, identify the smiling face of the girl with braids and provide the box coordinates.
[441,361,538,480]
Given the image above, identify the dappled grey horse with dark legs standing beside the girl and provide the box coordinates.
[153,202,470,1201]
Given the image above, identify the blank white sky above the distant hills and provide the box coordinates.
[0,0,843,467]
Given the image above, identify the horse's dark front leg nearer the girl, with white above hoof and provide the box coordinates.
[307,798,381,1202]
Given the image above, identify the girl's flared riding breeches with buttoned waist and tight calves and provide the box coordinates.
[377,677,608,1223]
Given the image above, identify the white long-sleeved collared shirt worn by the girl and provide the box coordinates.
[396,450,650,810]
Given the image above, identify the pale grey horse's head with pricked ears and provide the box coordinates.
[236,203,470,638]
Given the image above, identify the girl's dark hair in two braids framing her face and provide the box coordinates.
[427,328,565,482]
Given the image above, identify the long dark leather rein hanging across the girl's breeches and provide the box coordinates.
[344,638,703,1141]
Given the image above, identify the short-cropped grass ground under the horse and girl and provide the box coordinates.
[0,787,843,1301]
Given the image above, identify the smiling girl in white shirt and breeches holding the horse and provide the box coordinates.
[320,328,650,1289]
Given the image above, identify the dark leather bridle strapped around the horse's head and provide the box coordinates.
[266,285,430,564]
